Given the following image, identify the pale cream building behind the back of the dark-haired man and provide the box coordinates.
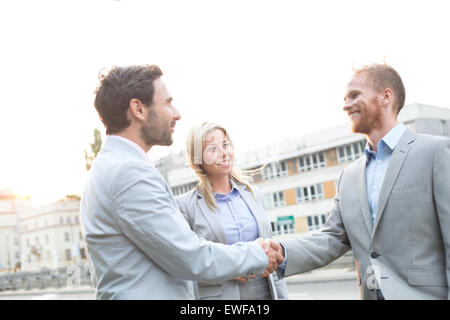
[18,200,87,271]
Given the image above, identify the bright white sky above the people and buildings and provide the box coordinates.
[0,0,450,205]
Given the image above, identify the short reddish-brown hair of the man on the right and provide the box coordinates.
[354,63,406,115]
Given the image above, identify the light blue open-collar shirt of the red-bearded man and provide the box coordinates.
[365,123,406,225]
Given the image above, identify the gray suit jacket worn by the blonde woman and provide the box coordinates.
[176,184,288,300]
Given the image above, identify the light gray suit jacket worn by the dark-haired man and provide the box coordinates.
[81,137,268,299]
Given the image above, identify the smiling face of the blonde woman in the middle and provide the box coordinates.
[201,129,234,177]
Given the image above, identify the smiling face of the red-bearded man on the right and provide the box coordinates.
[343,73,382,134]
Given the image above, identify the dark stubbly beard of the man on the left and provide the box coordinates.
[139,109,173,146]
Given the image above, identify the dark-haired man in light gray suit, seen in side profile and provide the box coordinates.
[81,66,283,299]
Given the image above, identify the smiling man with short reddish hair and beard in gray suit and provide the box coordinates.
[278,64,450,300]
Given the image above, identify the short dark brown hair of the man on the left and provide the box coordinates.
[94,65,162,134]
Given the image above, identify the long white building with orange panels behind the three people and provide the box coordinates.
[156,104,450,238]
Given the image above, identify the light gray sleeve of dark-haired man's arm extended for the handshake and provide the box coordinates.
[112,163,268,281]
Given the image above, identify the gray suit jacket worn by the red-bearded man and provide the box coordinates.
[284,129,450,299]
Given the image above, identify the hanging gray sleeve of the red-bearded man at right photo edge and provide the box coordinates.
[433,139,450,300]
